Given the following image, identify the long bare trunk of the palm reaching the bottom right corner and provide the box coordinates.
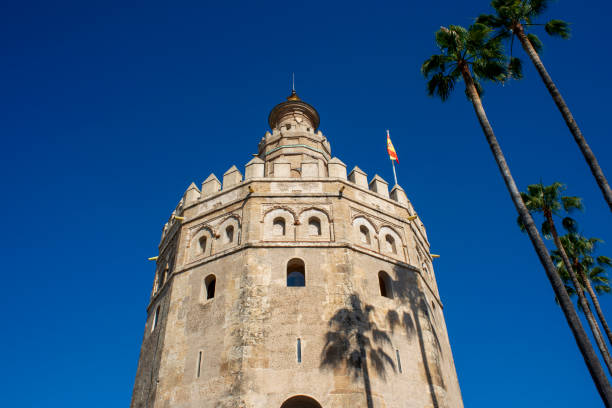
[461,65,612,408]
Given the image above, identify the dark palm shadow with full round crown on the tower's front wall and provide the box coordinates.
[321,294,395,408]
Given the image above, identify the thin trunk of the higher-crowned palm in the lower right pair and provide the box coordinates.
[544,209,612,374]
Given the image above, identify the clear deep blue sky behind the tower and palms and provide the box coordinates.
[0,0,612,408]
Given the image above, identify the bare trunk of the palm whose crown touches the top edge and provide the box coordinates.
[514,24,612,211]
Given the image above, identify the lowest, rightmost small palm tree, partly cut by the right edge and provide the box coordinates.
[553,232,612,344]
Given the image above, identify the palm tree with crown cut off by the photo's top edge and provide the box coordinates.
[476,0,612,211]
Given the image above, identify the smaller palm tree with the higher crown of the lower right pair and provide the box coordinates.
[519,182,612,374]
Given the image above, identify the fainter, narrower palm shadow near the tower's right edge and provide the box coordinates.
[387,267,446,408]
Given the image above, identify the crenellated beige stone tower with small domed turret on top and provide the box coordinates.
[131,92,463,408]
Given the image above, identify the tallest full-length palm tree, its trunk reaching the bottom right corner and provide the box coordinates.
[421,24,612,407]
